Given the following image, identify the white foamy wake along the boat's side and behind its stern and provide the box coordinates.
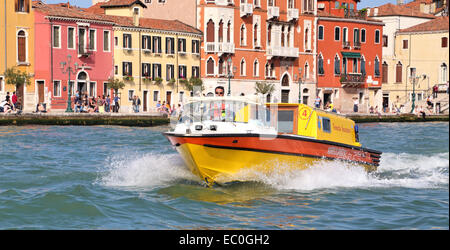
[230,153,449,190]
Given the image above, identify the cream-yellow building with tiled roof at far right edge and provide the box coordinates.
[382,16,449,112]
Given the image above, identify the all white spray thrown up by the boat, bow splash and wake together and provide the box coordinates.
[97,150,449,191]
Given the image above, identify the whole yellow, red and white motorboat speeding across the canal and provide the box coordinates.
[164,97,382,185]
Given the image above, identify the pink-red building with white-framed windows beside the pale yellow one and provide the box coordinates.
[33,2,114,110]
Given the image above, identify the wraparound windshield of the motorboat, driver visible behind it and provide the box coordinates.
[178,99,270,126]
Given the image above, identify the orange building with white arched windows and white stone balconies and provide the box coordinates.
[197,0,316,104]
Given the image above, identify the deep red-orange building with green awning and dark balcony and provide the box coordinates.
[317,0,384,113]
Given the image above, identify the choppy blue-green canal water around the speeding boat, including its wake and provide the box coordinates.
[0,123,449,230]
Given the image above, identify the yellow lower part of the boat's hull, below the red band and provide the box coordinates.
[177,143,368,184]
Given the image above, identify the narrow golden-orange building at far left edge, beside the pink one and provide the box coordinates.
[0,0,37,111]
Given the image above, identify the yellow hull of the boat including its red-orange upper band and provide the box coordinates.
[165,133,381,183]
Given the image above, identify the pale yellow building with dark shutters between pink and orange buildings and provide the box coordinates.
[86,1,202,112]
